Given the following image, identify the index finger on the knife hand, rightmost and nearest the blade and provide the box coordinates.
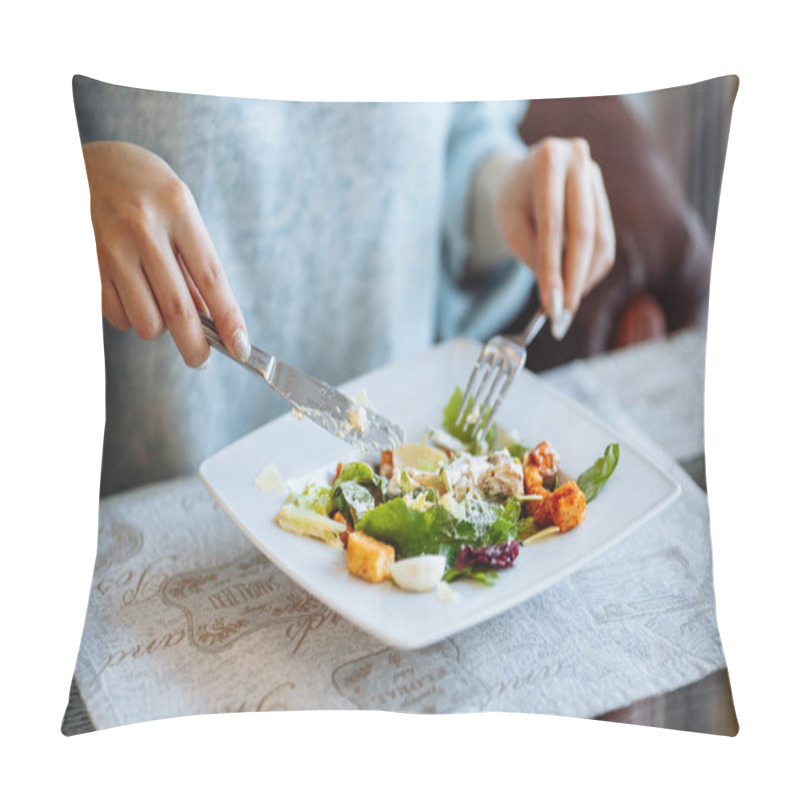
[174,202,250,361]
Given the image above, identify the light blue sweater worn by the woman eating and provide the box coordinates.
[73,76,532,494]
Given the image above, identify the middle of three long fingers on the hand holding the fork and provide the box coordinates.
[564,143,596,316]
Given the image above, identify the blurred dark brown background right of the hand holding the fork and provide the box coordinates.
[507,75,739,371]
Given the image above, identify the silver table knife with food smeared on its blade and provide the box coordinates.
[200,314,405,453]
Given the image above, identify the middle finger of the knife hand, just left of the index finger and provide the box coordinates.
[141,234,210,367]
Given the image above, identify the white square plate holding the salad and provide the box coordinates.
[200,339,680,649]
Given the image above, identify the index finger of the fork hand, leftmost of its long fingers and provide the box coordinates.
[533,139,566,319]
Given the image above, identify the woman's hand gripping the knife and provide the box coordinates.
[83,142,250,367]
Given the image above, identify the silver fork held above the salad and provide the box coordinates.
[456,308,547,442]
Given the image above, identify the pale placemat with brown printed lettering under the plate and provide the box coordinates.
[64,330,725,733]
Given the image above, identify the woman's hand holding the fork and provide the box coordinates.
[495,138,616,339]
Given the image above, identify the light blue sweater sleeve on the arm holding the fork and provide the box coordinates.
[438,101,533,339]
